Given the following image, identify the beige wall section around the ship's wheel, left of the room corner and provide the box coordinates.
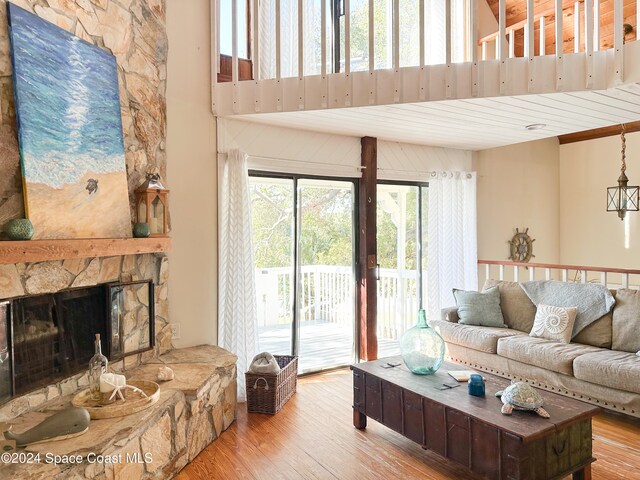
[474,137,561,263]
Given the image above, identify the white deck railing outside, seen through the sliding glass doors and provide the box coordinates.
[256,265,419,340]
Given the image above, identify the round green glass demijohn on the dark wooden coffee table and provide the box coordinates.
[400,309,444,375]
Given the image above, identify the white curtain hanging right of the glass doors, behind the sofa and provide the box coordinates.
[427,172,478,318]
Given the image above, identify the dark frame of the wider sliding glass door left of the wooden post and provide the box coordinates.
[248,169,360,373]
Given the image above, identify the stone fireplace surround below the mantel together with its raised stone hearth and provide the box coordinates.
[0,251,237,479]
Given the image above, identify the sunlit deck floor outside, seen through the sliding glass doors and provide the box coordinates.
[259,322,400,373]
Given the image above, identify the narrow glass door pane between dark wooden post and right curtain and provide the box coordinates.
[377,183,428,357]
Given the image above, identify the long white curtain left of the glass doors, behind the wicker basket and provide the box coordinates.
[218,150,258,402]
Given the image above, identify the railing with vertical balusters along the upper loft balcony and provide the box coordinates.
[211,0,640,112]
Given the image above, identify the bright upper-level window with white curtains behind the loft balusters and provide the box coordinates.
[258,0,470,78]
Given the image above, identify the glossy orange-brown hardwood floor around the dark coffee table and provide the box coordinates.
[177,369,640,480]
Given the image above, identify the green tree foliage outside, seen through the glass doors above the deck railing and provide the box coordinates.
[251,179,426,270]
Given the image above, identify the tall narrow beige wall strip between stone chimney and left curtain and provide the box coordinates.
[167,0,217,347]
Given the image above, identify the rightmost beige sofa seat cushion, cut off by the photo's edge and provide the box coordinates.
[573,350,640,393]
